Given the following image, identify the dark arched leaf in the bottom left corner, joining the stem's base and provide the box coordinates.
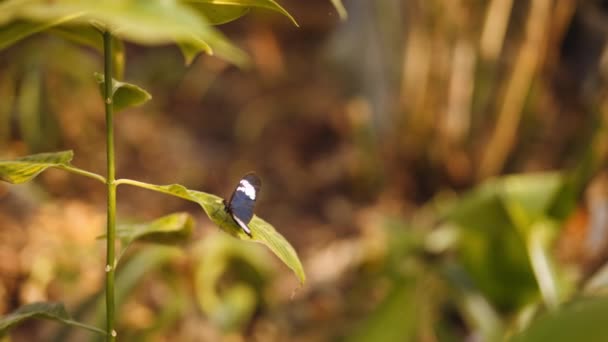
[0,302,106,336]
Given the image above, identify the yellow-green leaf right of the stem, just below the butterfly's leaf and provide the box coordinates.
[116,213,194,245]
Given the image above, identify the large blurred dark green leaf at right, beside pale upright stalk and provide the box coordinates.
[444,178,538,311]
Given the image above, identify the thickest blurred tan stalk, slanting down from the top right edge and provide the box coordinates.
[478,0,552,179]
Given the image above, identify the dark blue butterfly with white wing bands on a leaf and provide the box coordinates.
[224,172,262,237]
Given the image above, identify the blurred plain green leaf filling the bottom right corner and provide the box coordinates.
[510,297,608,342]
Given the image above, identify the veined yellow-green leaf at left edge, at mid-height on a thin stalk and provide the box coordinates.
[0,151,74,184]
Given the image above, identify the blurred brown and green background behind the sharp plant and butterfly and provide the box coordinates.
[0,0,608,341]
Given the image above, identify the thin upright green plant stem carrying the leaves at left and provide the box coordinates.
[103,30,116,341]
